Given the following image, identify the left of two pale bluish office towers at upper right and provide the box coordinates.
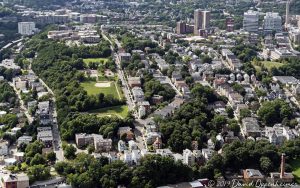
[243,10,259,33]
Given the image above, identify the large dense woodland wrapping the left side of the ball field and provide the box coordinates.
[30,40,124,122]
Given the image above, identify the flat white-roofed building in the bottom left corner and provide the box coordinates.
[0,173,29,188]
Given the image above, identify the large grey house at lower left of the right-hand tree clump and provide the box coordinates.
[241,117,261,138]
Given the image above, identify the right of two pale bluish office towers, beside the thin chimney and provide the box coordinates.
[263,12,282,32]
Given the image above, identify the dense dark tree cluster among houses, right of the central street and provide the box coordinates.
[159,84,226,152]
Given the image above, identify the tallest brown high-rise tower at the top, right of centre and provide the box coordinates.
[194,9,210,35]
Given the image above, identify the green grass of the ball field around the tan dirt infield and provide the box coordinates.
[80,81,122,99]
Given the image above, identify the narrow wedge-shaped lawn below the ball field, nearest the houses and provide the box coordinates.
[89,105,128,118]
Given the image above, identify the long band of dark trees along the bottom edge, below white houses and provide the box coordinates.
[55,153,193,188]
